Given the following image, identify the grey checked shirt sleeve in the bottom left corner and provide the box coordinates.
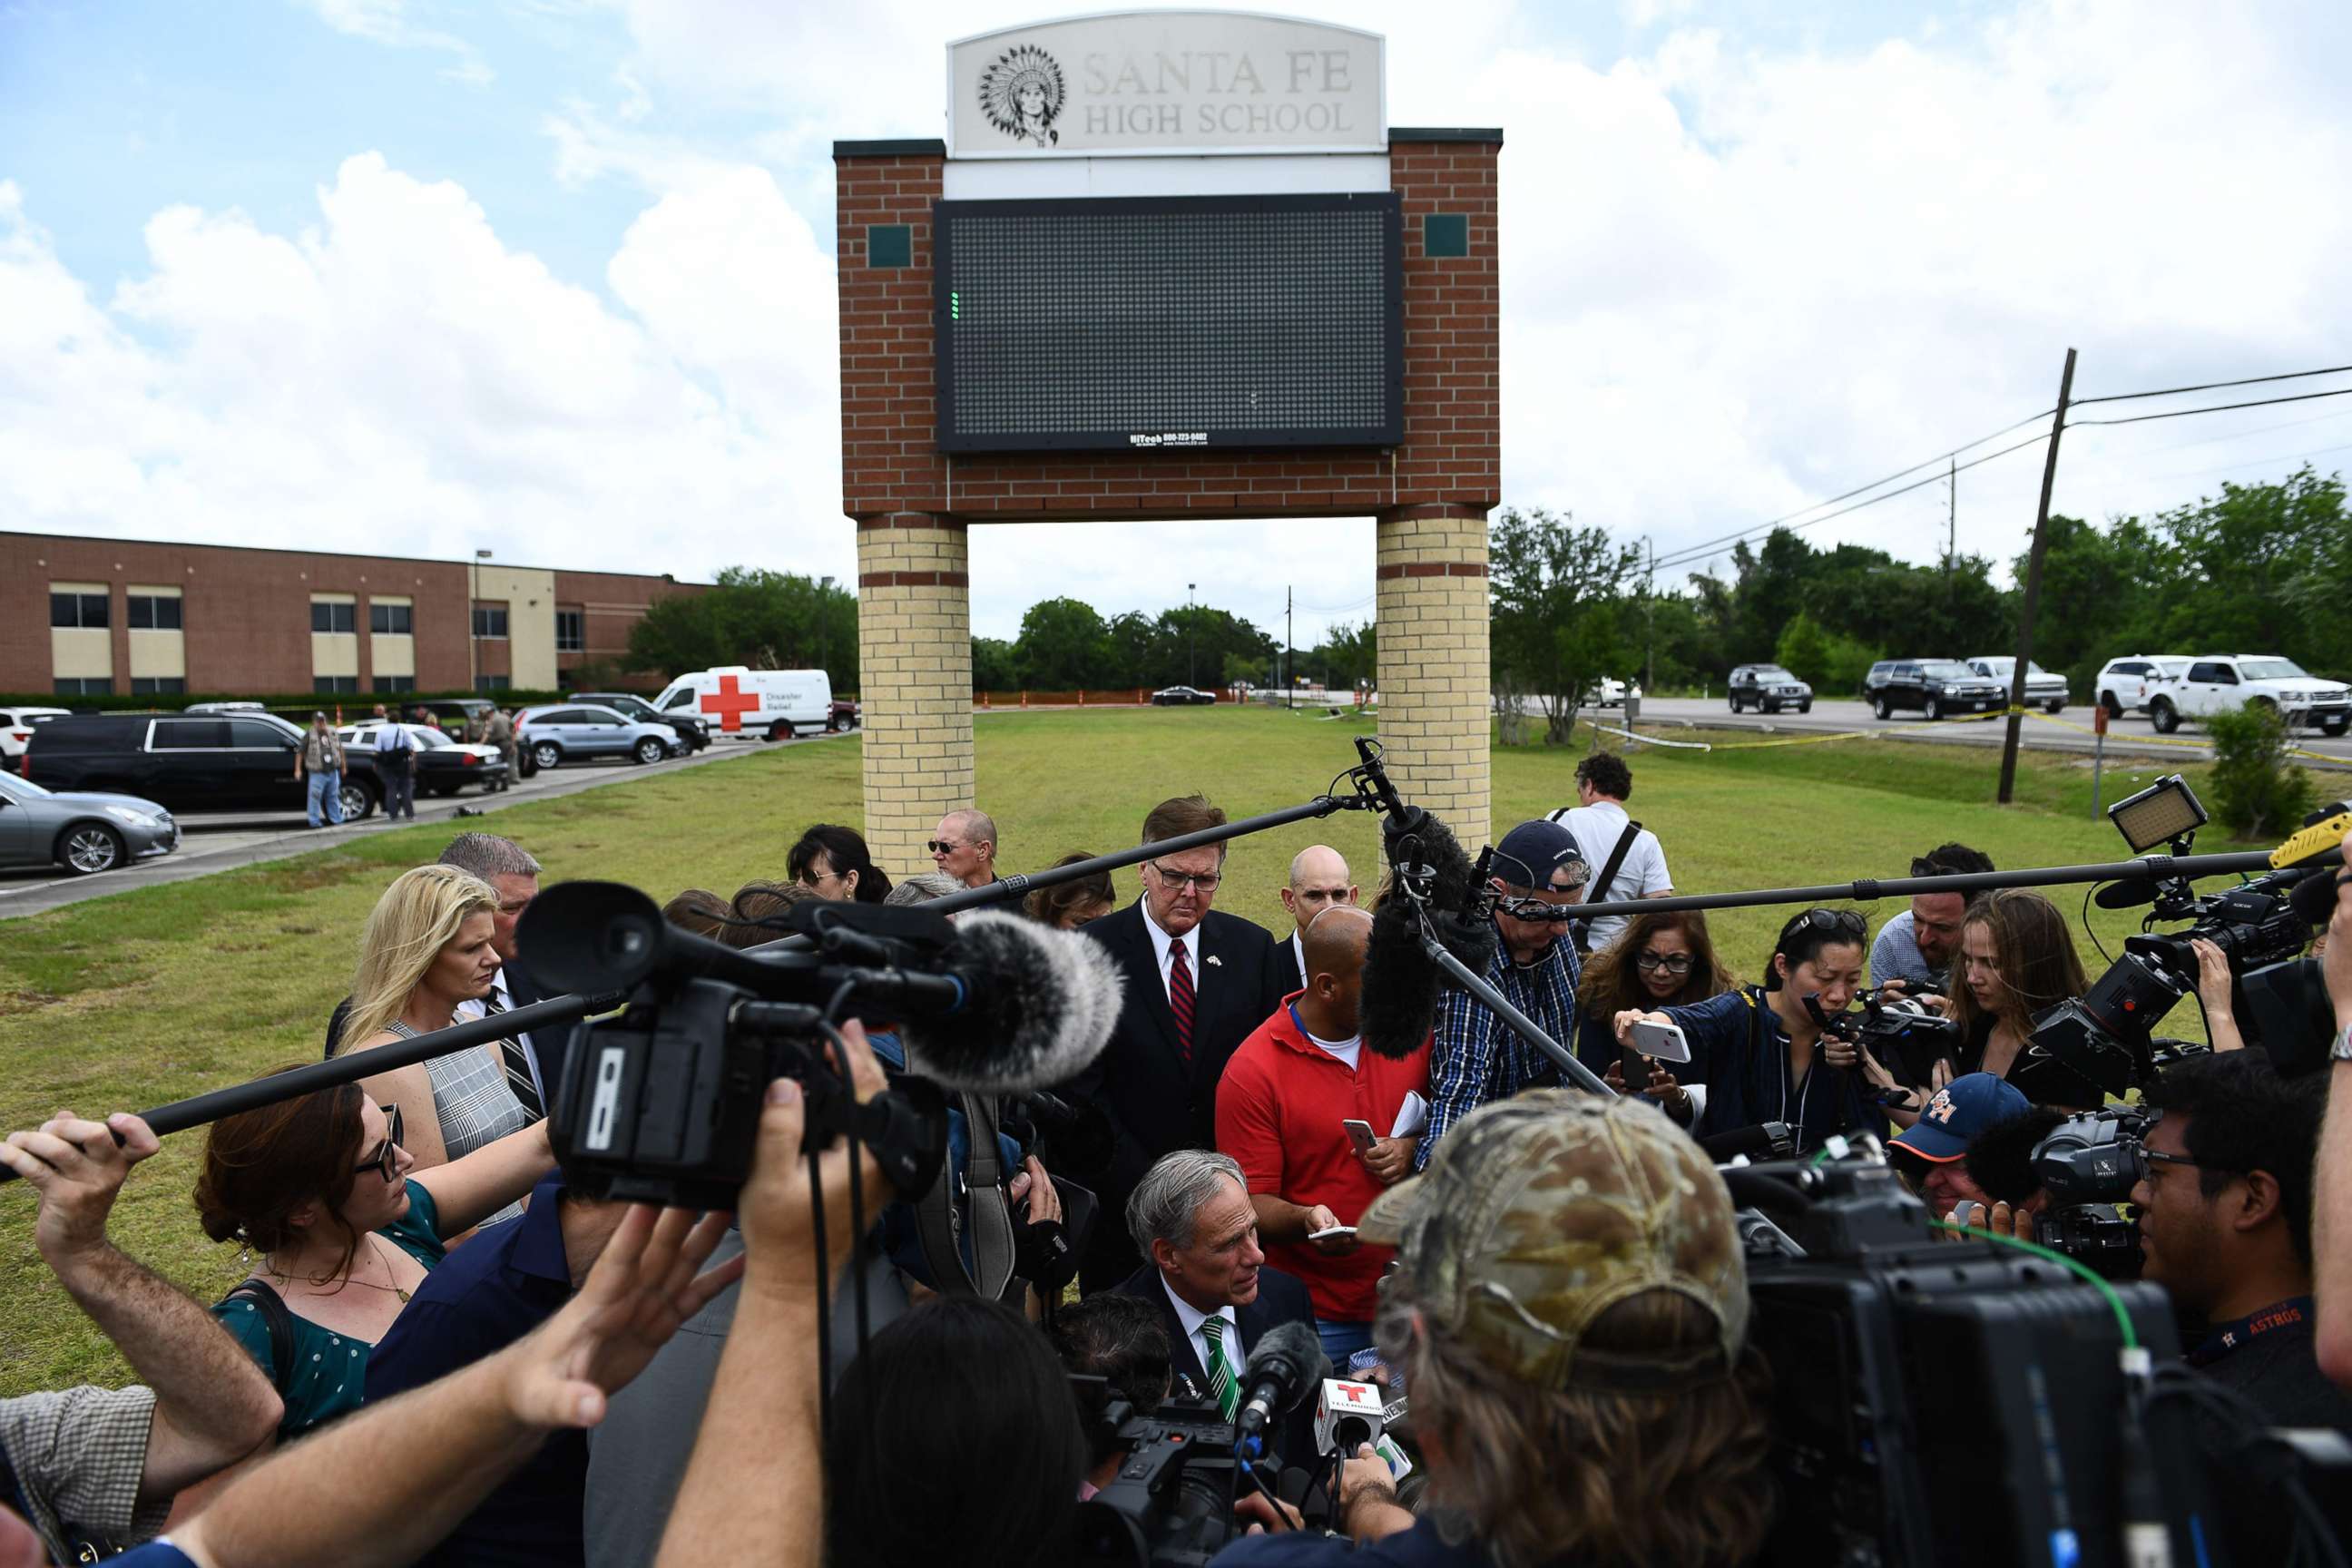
[0,1385,172,1563]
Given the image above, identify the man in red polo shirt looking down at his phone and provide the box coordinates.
[1216,907,1430,1368]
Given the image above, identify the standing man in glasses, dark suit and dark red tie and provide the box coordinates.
[1073,795,1287,1290]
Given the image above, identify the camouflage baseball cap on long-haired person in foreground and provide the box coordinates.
[1357,1088,1748,1392]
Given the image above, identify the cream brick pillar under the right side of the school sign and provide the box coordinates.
[1376,505,1494,856]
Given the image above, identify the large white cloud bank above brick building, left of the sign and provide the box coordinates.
[0,155,849,587]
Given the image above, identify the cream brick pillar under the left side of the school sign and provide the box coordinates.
[858,513,974,877]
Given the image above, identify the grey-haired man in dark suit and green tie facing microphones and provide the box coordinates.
[1117,1150,1315,1467]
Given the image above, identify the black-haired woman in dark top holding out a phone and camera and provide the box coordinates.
[1613,910,1886,1150]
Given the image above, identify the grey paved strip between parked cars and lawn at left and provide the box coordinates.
[0,736,830,919]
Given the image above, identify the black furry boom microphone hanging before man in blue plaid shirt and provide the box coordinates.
[1362,808,1496,1060]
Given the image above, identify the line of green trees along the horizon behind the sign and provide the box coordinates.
[628,466,2352,710]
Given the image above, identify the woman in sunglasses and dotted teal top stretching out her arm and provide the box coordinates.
[195,1067,555,1439]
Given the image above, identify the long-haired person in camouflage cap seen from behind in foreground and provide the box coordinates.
[1216,1088,1771,1568]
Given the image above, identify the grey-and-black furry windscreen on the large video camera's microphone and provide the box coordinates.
[903,910,1122,1093]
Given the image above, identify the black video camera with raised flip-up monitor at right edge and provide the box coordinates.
[2032,773,2345,1095]
